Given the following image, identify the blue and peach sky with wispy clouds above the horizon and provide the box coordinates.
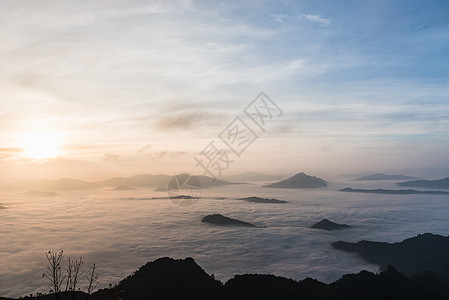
[0,0,449,180]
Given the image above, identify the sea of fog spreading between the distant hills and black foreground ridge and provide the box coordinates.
[0,181,449,297]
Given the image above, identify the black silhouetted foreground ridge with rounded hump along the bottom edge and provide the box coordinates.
[6,241,449,300]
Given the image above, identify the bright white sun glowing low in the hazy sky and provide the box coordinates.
[22,131,61,159]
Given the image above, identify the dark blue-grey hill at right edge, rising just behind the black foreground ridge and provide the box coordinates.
[332,233,449,280]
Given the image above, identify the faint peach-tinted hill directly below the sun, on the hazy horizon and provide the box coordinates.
[7,178,99,191]
